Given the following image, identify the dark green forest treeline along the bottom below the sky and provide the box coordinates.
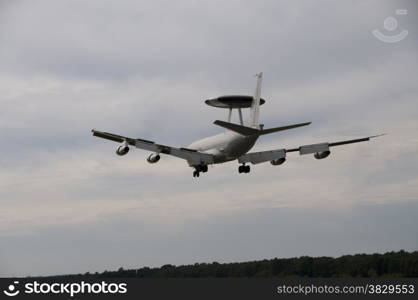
[59,250,418,278]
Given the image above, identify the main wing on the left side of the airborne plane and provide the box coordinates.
[92,129,213,166]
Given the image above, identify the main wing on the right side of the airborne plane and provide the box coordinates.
[238,134,384,164]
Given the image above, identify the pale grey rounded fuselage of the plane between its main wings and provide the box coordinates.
[187,131,258,164]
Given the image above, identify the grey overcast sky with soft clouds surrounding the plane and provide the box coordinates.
[0,0,418,276]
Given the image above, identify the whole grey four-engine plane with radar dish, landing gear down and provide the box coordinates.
[92,73,386,177]
